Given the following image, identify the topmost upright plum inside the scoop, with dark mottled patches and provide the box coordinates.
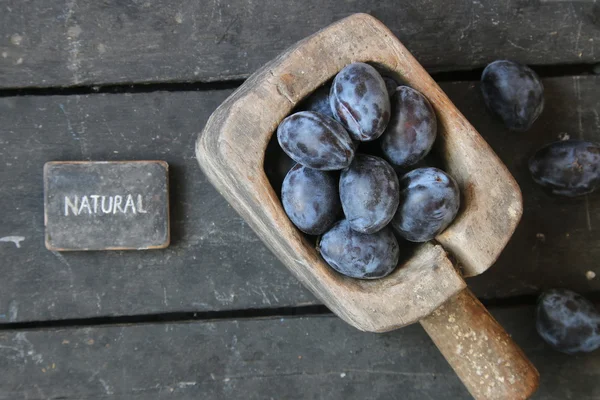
[329,63,390,141]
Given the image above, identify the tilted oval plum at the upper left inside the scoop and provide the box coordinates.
[277,111,354,171]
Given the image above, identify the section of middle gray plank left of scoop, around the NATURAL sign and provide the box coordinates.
[0,91,315,322]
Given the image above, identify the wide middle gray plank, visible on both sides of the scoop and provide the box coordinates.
[0,76,600,322]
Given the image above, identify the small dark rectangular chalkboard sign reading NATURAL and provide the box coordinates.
[44,161,169,251]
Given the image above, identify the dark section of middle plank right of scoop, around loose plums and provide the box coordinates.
[443,77,600,298]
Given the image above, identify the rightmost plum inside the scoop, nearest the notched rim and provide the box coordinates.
[391,168,460,242]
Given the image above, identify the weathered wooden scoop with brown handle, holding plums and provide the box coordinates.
[196,14,539,400]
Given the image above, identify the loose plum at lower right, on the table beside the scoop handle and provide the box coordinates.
[535,289,600,354]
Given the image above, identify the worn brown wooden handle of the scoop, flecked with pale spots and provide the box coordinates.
[420,289,540,400]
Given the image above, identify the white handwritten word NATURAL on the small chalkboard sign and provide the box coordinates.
[65,194,148,216]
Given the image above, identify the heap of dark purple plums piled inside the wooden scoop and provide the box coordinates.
[277,63,460,279]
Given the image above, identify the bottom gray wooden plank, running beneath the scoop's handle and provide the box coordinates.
[0,307,600,400]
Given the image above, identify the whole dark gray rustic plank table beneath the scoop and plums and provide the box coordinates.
[0,0,600,399]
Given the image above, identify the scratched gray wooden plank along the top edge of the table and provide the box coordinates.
[0,0,600,88]
